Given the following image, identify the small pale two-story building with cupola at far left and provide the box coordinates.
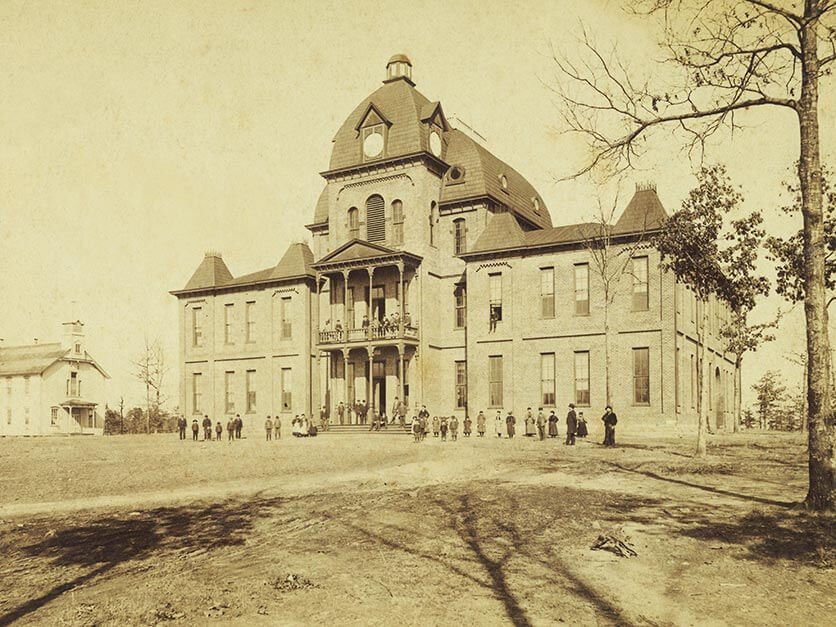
[0,320,110,435]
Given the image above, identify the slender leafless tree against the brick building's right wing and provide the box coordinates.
[579,189,647,405]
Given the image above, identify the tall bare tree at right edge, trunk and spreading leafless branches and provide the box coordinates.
[554,0,836,510]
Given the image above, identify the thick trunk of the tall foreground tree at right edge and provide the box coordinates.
[796,9,836,510]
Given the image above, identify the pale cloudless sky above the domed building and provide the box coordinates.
[0,0,836,405]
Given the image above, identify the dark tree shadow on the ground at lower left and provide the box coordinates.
[0,498,283,625]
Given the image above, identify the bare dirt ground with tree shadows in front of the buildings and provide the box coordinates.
[0,433,836,625]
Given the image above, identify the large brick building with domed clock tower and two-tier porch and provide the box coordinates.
[172,55,735,432]
